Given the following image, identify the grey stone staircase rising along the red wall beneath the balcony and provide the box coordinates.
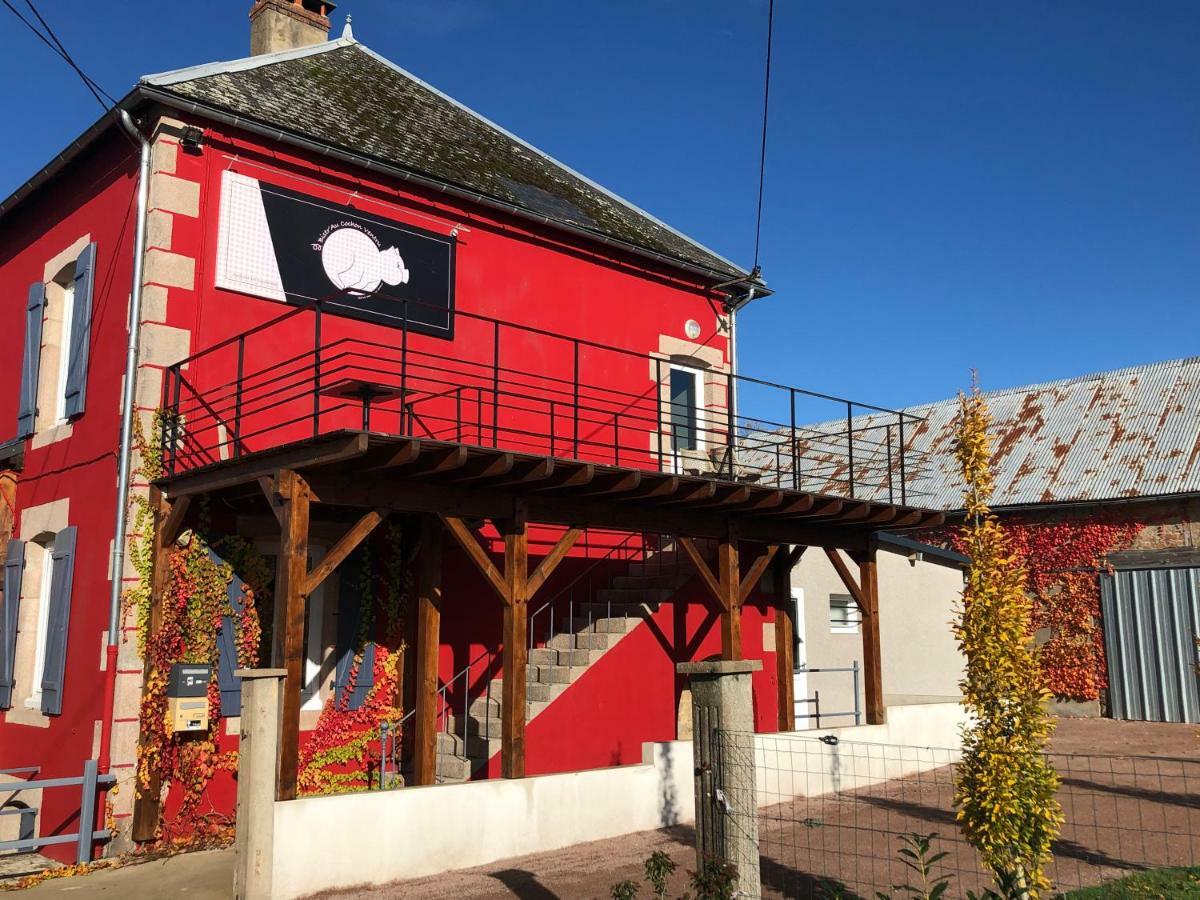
[437,547,690,782]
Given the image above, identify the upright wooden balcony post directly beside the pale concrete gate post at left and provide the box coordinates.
[274,469,308,800]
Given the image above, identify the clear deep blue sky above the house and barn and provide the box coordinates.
[0,0,1200,406]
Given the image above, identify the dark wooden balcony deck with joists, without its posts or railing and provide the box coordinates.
[160,432,942,550]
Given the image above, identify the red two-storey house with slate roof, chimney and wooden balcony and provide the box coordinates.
[0,0,936,852]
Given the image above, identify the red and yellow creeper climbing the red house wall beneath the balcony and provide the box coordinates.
[125,416,410,846]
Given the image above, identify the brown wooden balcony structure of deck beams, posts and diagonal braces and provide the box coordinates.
[134,432,942,840]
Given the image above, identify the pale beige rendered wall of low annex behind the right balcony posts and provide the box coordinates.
[792,550,964,728]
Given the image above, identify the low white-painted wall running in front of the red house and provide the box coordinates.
[267,703,962,900]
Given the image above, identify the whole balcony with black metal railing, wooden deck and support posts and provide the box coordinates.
[134,301,942,834]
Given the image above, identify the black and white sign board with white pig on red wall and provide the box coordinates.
[217,173,456,337]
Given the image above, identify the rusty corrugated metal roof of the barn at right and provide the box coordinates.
[753,356,1200,510]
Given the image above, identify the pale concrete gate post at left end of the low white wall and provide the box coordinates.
[233,668,287,900]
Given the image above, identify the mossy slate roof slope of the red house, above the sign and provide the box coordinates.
[142,37,745,277]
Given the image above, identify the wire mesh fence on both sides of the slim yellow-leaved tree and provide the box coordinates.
[700,732,1200,900]
